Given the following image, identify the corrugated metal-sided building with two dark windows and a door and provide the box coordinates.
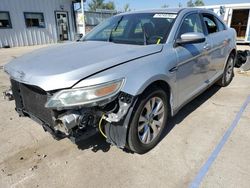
[0,0,81,48]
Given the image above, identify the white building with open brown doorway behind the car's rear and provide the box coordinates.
[201,3,250,43]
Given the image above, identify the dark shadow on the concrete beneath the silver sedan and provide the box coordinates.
[76,86,220,153]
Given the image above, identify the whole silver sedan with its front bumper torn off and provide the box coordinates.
[4,8,236,154]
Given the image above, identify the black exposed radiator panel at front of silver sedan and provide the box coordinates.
[11,80,53,126]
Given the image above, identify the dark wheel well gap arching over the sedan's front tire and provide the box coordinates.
[143,80,172,116]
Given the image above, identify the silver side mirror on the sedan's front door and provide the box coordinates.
[176,32,206,45]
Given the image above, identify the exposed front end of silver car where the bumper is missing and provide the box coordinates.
[4,80,137,148]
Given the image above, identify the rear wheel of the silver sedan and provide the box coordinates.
[217,54,235,87]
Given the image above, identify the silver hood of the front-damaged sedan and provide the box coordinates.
[4,41,162,91]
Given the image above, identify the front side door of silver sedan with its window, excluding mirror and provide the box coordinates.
[175,13,210,105]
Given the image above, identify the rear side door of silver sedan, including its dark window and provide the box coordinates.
[202,13,231,82]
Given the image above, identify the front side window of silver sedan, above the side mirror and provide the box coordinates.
[178,14,203,38]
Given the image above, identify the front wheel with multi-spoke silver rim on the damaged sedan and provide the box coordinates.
[128,87,168,154]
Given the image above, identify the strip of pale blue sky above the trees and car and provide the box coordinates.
[86,0,249,11]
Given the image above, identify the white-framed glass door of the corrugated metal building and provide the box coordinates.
[56,12,69,41]
